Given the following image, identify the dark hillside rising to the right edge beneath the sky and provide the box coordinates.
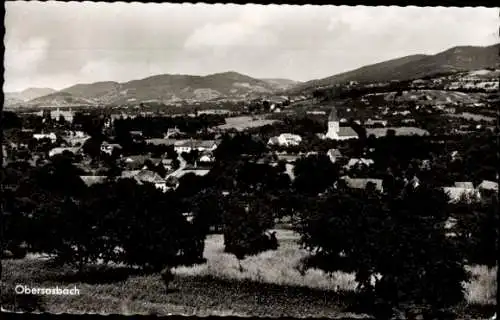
[295,44,500,90]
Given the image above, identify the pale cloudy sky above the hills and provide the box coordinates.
[4,2,499,91]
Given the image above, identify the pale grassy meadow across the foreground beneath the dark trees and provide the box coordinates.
[1,230,496,319]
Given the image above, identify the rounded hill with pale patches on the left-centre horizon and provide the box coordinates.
[26,72,275,105]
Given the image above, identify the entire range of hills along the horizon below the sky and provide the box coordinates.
[5,44,500,106]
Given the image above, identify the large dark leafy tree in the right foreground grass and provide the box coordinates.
[297,182,467,316]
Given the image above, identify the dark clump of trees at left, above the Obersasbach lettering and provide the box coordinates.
[2,159,205,270]
